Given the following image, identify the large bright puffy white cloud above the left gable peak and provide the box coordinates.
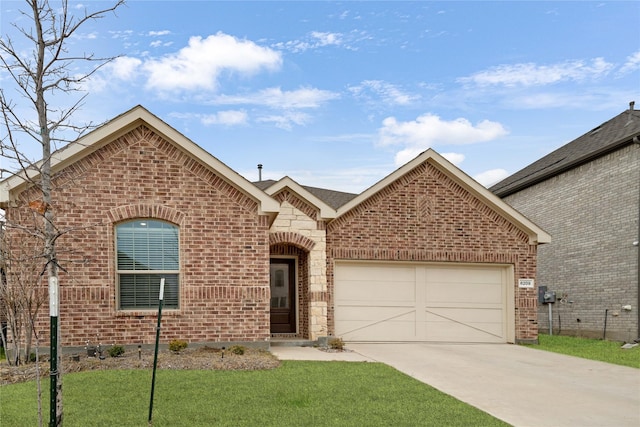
[144,33,282,91]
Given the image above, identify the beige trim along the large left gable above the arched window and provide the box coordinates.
[0,106,279,213]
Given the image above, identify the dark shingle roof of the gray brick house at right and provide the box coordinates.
[489,104,640,197]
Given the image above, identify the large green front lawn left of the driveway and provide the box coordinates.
[0,361,507,427]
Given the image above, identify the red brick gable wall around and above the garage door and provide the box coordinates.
[327,162,538,342]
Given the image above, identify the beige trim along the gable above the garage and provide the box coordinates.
[336,149,551,244]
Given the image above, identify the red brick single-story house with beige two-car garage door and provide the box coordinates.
[0,106,550,347]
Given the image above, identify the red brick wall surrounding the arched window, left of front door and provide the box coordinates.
[8,126,270,346]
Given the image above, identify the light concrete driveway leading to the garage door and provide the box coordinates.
[347,343,640,427]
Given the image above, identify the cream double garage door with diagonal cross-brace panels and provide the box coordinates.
[335,262,514,343]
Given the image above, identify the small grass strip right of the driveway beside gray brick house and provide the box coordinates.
[531,334,640,368]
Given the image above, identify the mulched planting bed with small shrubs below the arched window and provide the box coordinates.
[0,346,280,385]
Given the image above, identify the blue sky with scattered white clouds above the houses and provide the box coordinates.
[0,0,640,193]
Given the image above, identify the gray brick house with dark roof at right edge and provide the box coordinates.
[491,103,640,341]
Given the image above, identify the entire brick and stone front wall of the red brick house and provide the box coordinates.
[2,118,538,347]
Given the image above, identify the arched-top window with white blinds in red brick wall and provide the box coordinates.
[116,219,180,310]
